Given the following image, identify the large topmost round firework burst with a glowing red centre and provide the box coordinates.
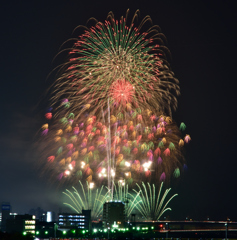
[52,10,179,120]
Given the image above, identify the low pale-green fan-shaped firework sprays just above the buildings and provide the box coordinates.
[63,181,178,221]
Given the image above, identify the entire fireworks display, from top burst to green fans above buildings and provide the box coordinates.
[41,11,191,220]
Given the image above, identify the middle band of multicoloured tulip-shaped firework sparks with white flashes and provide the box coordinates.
[42,100,189,184]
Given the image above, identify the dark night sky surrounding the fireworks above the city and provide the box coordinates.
[0,0,237,221]
